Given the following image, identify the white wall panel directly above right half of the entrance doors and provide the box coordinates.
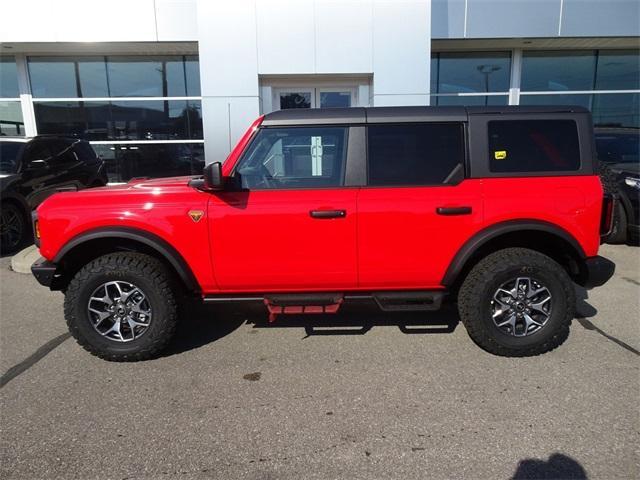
[315,0,373,73]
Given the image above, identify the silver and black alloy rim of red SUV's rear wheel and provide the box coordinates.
[491,277,553,337]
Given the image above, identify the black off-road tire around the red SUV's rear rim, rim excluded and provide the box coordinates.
[458,248,576,357]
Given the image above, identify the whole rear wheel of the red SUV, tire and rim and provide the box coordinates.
[458,248,575,357]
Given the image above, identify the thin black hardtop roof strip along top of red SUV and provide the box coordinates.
[262,105,589,127]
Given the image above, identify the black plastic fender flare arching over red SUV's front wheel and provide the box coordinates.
[53,227,200,292]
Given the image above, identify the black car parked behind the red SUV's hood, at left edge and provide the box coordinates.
[0,136,107,254]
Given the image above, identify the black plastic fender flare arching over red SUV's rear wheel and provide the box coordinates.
[441,220,586,286]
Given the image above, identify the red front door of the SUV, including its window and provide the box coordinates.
[208,126,357,292]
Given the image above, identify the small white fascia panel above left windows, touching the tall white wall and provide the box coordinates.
[156,0,198,42]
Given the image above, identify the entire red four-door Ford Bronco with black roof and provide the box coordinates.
[32,107,614,361]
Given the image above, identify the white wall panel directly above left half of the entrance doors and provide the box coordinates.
[254,0,315,74]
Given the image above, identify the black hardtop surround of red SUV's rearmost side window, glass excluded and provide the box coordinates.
[469,112,598,178]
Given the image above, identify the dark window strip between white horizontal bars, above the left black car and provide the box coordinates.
[34,100,202,140]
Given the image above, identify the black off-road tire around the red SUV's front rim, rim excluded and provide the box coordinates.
[64,252,178,362]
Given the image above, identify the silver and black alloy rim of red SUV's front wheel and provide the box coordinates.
[87,280,152,342]
